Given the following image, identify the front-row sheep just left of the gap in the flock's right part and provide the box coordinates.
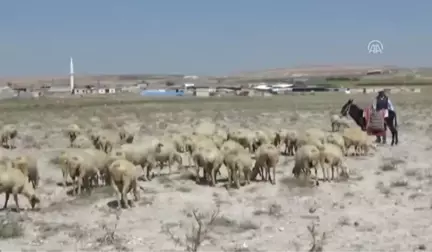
[251,144,280,185]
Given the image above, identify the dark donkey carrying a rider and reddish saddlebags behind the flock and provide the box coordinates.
[341,99,399,145]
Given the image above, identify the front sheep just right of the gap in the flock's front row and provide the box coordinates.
[292,144,325,185]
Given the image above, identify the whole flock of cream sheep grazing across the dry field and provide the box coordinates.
[0,115,375,210]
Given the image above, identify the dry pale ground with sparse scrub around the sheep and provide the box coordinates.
[0,94,432,252]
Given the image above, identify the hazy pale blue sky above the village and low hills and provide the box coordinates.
[0,0,432,76]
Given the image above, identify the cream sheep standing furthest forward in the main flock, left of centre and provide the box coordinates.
[108,159,140,208]
